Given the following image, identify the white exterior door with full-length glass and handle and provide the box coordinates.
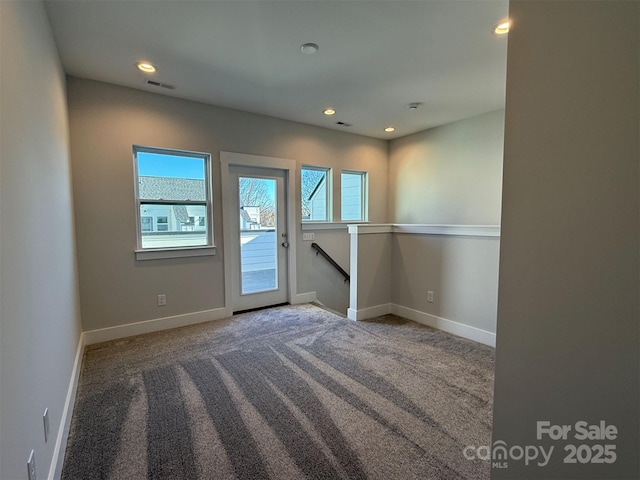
[226,165,289,312]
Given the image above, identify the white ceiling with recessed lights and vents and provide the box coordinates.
[46,0,508,139]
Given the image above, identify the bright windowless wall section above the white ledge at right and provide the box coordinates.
[389,110,504,225]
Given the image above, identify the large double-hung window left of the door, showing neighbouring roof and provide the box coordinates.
[133,146,213,249]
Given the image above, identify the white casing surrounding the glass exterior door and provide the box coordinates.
[220,152,300,317]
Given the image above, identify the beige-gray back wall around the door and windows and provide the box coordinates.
[68,78,388,330]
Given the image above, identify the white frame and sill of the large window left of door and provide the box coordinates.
[132,145,216,260]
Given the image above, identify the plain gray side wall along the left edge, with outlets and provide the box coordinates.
[0,1,80,479]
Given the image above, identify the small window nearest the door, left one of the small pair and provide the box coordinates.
[300,166,331,222]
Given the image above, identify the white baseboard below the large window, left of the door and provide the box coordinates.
[84,308,231,345]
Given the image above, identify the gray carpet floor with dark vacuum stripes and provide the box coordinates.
[62,304,494,480]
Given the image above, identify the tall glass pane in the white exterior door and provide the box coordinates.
[238,176,278,295]
